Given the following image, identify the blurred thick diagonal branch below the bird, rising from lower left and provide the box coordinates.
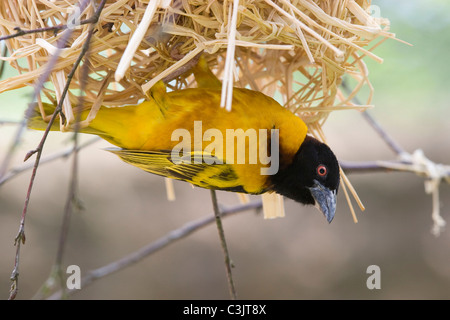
[44,201,262,300]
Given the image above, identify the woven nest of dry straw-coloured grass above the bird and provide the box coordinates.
[0,0,395,219]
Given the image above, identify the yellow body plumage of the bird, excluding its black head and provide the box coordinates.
[29,62,307,194]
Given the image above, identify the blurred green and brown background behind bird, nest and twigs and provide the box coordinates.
[0,0,450,299]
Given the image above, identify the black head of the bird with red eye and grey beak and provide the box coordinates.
[272,136,340,222]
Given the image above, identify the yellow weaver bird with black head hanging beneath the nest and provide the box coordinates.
[28,59,340,222]
